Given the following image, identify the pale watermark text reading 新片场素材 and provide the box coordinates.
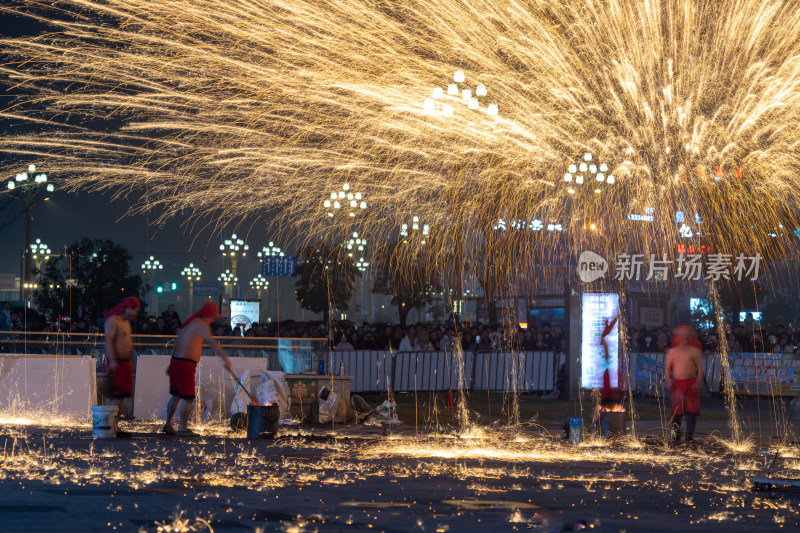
[614,254,761,281]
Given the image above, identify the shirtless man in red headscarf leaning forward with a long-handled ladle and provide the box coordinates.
[162,302,233,437]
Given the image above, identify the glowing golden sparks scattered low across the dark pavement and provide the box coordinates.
[0,422,800,523]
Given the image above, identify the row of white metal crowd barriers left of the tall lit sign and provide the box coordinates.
[330,350,566,392]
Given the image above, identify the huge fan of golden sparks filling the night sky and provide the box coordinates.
[0,0,800,276]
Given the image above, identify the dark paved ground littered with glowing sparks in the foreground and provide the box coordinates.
[0,402,800,532]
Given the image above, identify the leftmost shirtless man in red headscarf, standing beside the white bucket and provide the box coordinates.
[105,296,141,437]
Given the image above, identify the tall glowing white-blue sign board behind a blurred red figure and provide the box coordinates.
[581,293,619,389]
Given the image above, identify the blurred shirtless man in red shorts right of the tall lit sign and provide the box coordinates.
[664,326,703,443]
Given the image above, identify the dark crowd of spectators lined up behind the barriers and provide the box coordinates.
[0,302,800,353]
